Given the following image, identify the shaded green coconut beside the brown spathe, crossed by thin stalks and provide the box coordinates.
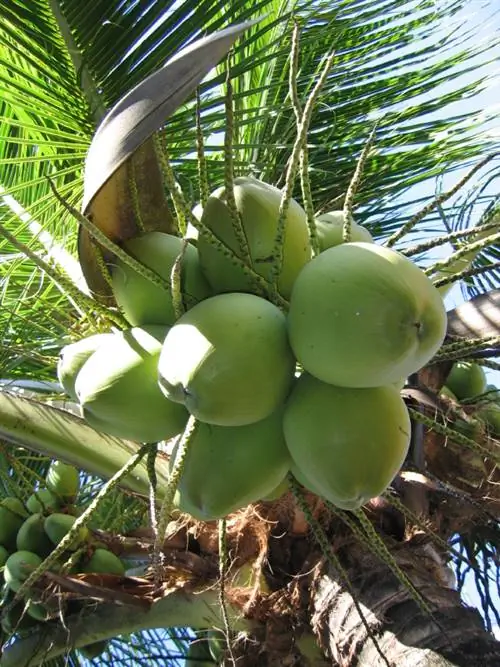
[112,232,211,326]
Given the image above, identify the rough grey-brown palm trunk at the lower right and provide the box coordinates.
[311,536,500,667]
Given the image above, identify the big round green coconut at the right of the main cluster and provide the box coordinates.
[288,243,447,387]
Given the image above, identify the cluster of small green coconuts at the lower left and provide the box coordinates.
[0,461,125,648]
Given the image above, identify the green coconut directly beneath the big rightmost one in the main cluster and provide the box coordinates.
[283,374,411,510]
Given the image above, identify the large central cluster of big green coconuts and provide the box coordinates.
[58,178,446,520]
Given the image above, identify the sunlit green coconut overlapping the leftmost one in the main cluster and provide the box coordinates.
[76,325,188,442]
